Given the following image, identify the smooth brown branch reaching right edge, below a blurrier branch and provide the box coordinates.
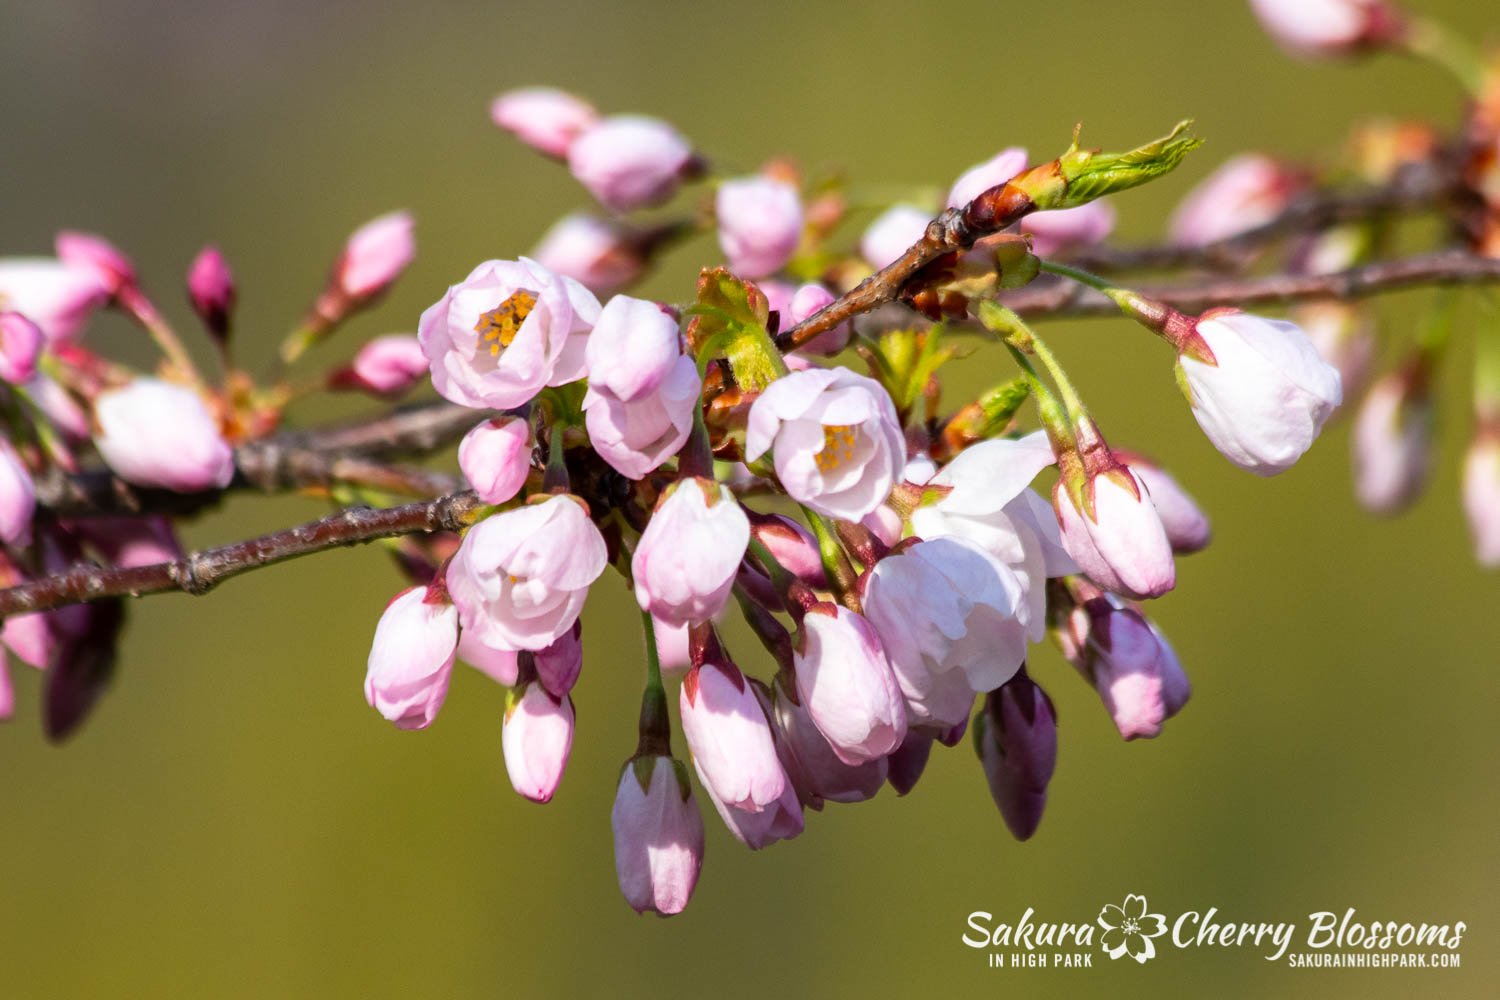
[1002,250,1500,319]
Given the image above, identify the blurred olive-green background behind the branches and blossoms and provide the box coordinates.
[0,0,1500,999]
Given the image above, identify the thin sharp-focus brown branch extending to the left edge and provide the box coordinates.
[0,490,483,616]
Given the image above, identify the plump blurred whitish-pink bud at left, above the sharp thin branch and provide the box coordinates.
[95,378,234,493]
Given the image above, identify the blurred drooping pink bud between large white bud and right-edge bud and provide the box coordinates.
[1350,369,1433,514]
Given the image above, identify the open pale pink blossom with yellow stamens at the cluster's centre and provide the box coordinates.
[746,367,906,520]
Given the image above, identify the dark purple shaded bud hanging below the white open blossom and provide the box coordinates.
[975,670,1058,840]
